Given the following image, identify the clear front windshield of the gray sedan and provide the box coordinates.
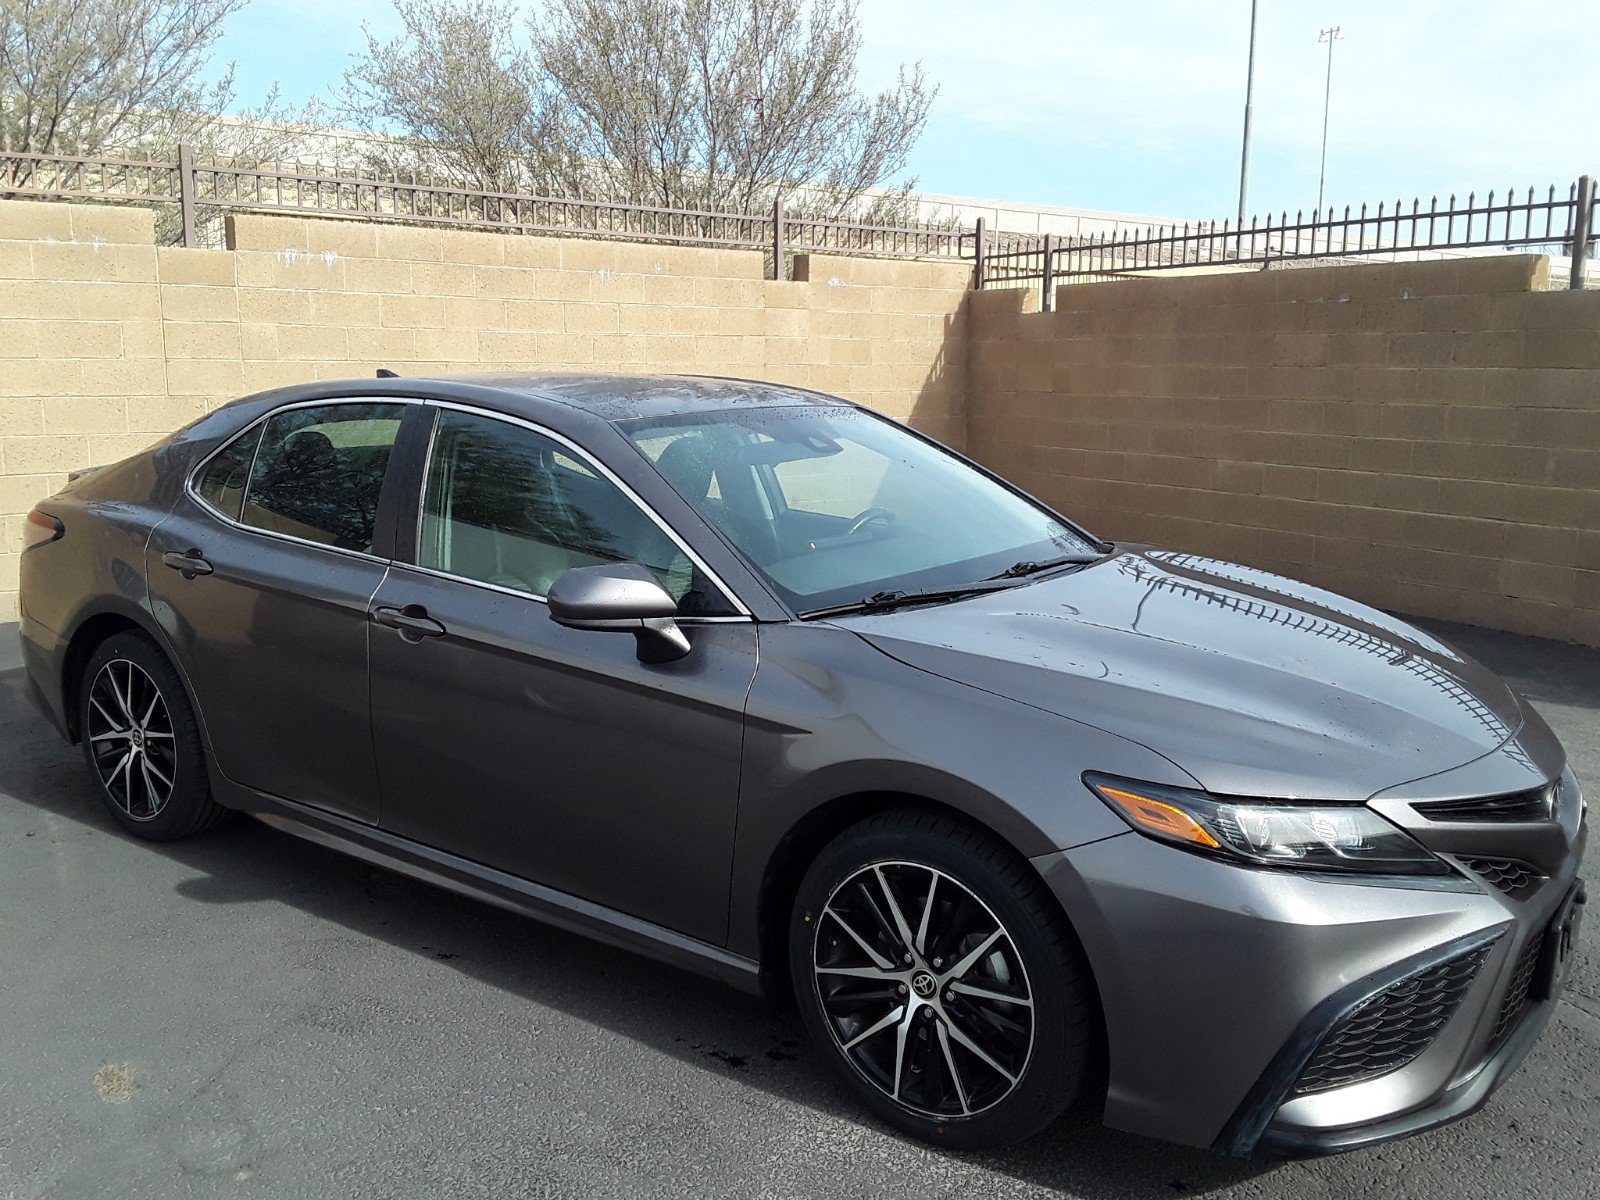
[622,405,1096,613]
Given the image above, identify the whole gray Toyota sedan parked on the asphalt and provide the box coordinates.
[22,376,1586,1155]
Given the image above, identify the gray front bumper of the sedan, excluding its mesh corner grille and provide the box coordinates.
[1035,774,1584,1157]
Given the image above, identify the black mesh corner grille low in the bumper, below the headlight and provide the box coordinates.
[1294,946,1491,1094]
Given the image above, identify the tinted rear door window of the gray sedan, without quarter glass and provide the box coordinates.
[240,405,405,552]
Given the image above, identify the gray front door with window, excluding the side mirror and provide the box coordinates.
[371,408,755,944]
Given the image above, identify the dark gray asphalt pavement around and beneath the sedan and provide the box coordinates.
[0,626,1600,1200]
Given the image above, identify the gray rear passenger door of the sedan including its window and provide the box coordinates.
[146,400,426,822]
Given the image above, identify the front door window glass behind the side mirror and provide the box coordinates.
[418,411,730,616]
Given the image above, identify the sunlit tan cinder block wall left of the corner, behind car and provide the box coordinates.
[0,202,971,621]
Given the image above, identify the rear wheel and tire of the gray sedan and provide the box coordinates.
[78,630,229,842]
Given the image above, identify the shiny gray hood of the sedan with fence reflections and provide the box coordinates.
[840,547,1523,800]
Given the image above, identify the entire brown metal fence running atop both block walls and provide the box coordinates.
[0,146,1597,300]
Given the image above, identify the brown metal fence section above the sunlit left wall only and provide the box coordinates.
[0,146,976,272]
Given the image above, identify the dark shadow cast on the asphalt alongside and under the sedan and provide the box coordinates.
[0,672,1274,1200]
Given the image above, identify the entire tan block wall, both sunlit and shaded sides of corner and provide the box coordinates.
[0,202,1600,645]
